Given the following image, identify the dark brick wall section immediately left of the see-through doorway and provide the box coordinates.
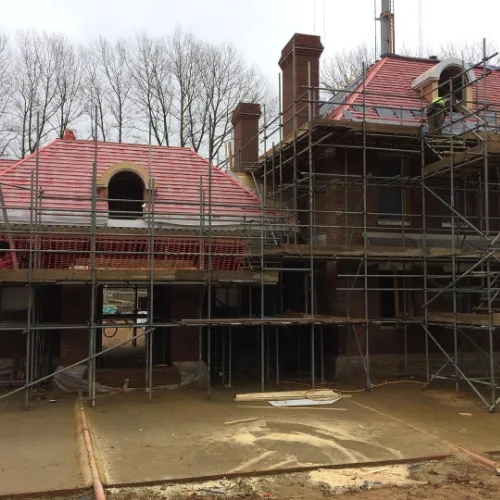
[61,285,91,365]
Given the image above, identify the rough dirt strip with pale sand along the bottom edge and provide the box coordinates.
[79,457,500,500]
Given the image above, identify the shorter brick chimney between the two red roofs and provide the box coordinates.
[231,102,262,172]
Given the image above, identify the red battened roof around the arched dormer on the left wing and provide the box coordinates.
[0,139,260,216]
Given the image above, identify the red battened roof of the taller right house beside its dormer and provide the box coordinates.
[326,56,500,121]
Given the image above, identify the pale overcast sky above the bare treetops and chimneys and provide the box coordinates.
[0,0,500,80]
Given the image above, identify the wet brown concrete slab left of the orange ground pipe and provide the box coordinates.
[0,395,90,495]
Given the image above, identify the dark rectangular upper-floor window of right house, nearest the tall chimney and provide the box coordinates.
[377,156,405,225]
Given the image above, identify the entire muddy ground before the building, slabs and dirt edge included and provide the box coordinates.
[0,376,500,500]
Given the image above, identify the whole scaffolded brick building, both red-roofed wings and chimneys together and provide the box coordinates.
[0,30,500,406]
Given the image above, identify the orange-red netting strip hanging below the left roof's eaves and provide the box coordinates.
[0,235,248,271]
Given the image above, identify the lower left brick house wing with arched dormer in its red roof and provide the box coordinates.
[0,134,280,382]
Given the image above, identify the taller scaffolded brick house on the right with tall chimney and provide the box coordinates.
[234,34,500,402]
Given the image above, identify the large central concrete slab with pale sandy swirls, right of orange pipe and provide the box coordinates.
[87,387,452,485]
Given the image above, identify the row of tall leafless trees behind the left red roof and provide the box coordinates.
[0,28,276,161]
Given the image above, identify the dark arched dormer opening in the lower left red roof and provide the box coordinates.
[108,170,145,219]
